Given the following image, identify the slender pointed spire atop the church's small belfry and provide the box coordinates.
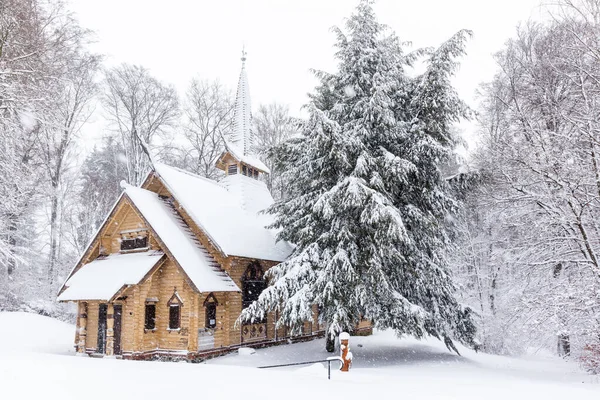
[231,50,254,156]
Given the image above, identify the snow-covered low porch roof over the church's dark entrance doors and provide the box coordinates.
[58,251,164,301]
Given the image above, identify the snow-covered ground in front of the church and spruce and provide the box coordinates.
[0,313,600,400]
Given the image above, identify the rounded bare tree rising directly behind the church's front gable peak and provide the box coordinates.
[102,64,179,184]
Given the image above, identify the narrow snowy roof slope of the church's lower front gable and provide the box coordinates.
[125,186,240,292]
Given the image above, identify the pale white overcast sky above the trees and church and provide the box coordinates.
[70,0,542,150]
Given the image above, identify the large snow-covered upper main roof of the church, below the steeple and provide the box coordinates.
[155,164,293,261]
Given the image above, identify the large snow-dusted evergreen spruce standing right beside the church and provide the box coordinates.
[240,1,474,348]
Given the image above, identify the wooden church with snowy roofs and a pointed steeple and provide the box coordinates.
[58,54,370,360]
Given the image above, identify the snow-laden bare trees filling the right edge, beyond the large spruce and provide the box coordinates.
[454,0,600,354]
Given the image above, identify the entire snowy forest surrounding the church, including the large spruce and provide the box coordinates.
[0,0,600,373]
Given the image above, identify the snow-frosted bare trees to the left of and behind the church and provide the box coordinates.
[0,0,296,314]
